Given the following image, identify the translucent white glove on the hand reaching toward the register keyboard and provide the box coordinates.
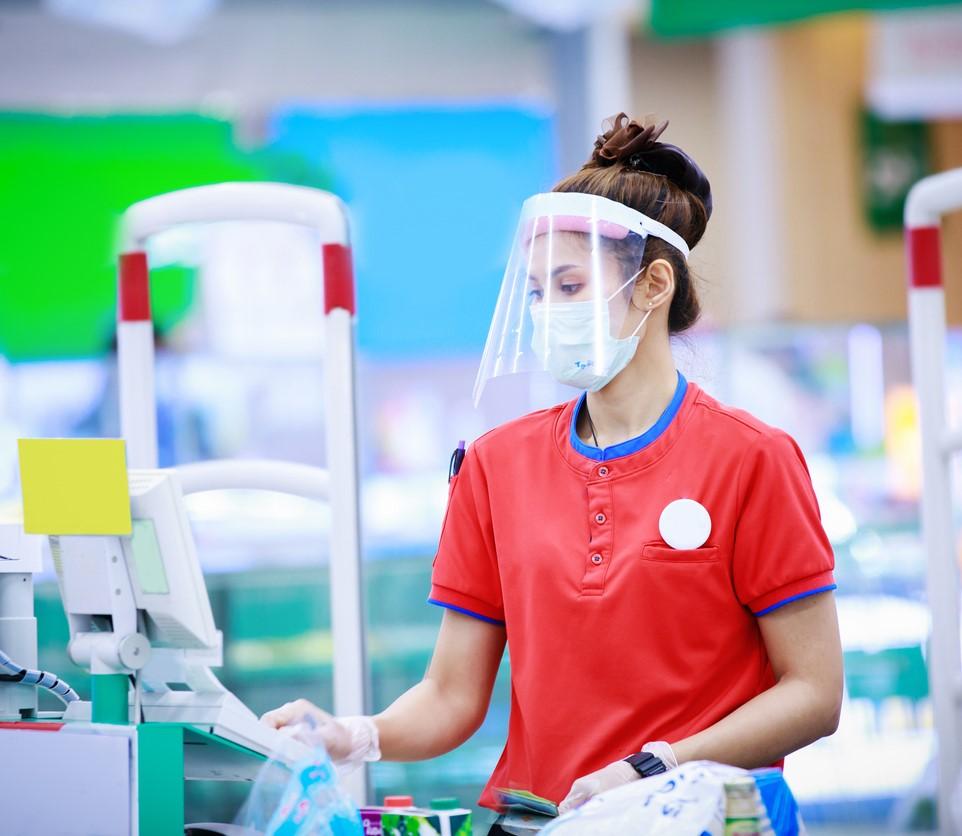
[261,700,381,765]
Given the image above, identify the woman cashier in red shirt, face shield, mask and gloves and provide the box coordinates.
[264,114,842,828]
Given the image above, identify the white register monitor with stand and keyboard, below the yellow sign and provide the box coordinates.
[50,470,306,764]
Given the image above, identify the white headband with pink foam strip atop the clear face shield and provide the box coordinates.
[521,192,691,259]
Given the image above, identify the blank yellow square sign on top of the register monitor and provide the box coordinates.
[18,438,131,535]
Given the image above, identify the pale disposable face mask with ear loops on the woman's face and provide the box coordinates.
[529,270,651,392]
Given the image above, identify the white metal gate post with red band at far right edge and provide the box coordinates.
[905,170,962,835]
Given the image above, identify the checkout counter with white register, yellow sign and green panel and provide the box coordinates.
[0,439,318,836]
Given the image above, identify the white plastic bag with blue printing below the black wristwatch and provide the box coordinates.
[541,761,748,836]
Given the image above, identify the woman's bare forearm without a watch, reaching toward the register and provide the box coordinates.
[374,678,484,761]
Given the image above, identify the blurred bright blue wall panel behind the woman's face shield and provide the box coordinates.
[271,105,557,359]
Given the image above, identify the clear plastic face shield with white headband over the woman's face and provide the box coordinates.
[474,192,688,405]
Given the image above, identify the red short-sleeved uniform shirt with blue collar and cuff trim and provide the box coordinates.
[431,375,835,807]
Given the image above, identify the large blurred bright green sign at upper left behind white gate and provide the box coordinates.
[0,114,325,361]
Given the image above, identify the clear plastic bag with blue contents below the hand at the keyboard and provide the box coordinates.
[234,747,363,836]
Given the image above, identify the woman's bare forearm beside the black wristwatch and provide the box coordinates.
[669,678,838,769]
